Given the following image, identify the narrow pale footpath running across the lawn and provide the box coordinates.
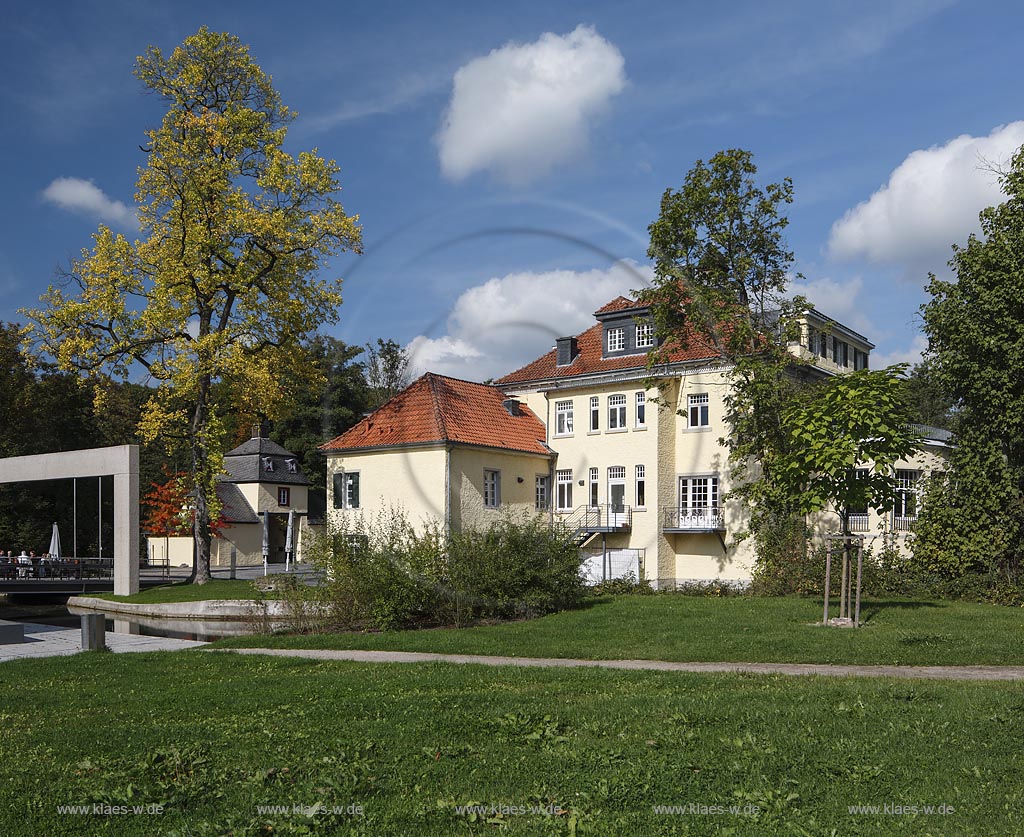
[210,648,1024,680]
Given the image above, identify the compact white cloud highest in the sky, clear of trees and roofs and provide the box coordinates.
[437,25,626,183]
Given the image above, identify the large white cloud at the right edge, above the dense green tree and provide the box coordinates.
[828,122,1024,270]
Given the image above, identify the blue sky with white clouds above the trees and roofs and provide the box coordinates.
[0,0,1024,379]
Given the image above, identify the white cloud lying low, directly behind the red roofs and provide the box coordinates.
[408,261,651,380]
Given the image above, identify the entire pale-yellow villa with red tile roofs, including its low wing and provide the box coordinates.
[323,297,947,588]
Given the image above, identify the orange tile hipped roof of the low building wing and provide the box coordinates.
[319,372,551,456]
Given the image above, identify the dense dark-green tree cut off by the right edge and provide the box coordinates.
[914,149,1024,580]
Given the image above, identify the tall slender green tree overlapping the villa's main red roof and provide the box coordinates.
[639,149,806,553]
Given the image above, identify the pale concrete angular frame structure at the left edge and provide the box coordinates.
[0,445,139,596]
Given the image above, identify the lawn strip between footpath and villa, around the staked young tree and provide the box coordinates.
[211,594,1024,666]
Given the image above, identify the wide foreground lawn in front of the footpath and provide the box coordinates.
[0,651,1024,837]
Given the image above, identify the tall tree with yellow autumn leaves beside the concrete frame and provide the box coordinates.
[19,28,360,584]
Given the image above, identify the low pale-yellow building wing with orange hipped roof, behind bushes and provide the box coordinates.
[321,373,554,530]
